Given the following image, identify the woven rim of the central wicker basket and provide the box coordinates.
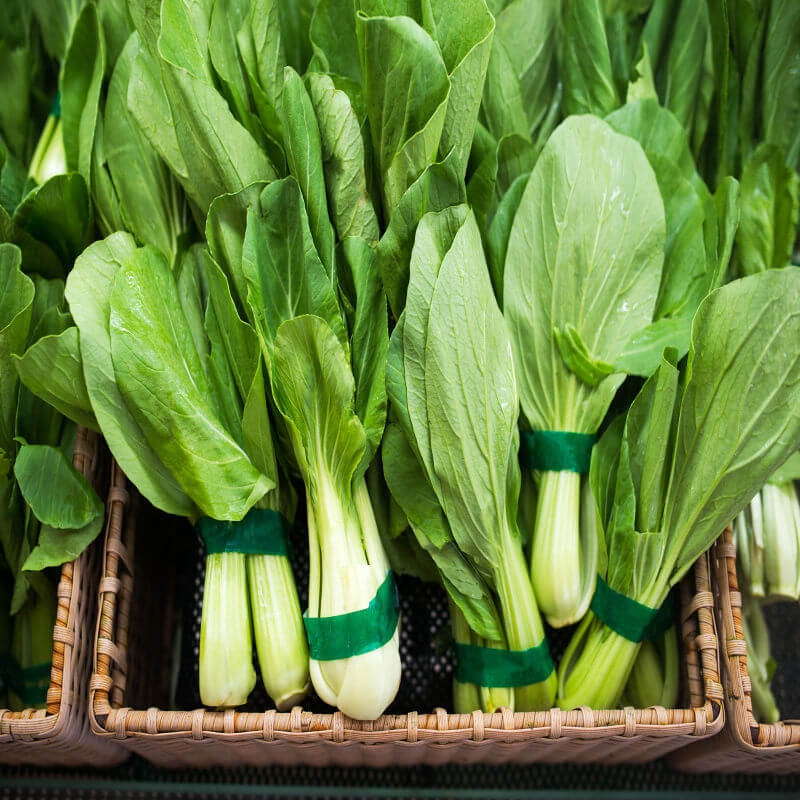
[89,464,725,747]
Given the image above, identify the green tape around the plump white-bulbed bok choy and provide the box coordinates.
[303,570,400,661]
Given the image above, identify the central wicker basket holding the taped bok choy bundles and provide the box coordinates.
[91,468,724,767]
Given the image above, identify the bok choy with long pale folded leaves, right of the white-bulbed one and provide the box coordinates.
[383,206,555,710]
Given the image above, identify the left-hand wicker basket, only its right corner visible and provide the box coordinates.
[0,428,128,766]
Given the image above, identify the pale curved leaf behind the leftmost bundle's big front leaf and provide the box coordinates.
[66,233,197,516]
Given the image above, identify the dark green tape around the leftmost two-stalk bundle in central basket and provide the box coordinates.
[195,508,292,556]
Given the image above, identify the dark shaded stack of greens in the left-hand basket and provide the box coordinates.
[0,2,104,711]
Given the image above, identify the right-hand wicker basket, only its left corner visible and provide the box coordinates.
[673,531,800,773]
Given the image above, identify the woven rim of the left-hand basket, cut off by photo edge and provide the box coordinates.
[0,427,99,747]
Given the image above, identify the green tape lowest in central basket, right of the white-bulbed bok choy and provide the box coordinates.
[455,639,553,688]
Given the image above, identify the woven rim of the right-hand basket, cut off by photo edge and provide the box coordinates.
[713,529,800,756]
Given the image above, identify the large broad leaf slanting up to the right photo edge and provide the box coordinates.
[664,267,800,583]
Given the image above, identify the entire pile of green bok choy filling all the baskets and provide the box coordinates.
[0,0,800,719]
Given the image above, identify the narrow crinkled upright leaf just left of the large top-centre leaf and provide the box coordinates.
[306,73,380,243]
